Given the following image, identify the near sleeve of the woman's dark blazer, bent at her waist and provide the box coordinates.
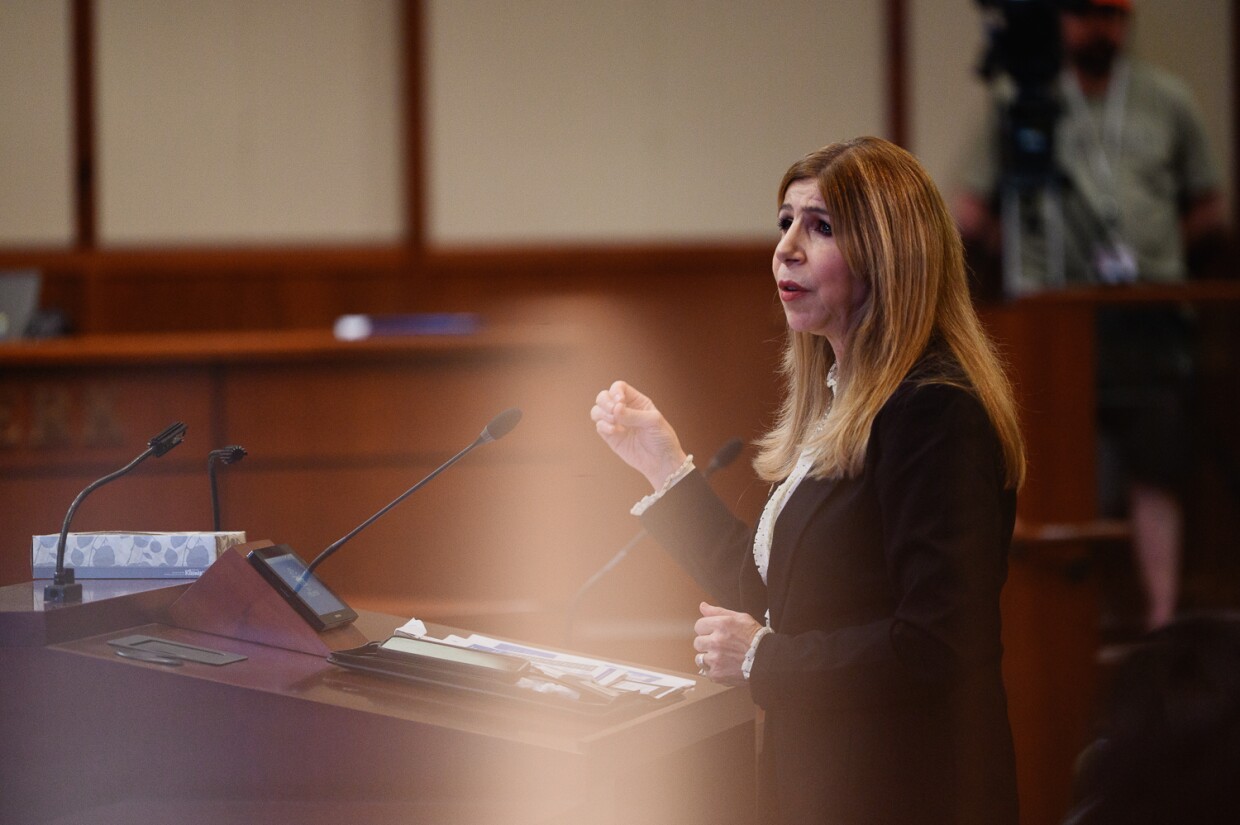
[749,386,1012,708]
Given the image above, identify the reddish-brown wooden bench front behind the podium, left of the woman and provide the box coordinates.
[0,289,780,635]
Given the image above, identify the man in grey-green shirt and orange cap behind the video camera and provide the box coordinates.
[955,0,1224,628]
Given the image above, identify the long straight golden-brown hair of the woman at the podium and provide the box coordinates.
[754,138,1025,488]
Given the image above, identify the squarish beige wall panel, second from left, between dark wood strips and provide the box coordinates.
[95,0,404,246]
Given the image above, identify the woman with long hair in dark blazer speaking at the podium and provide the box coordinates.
[590,138,1024,825]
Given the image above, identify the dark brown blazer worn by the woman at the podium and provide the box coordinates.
[642,381,1017,825]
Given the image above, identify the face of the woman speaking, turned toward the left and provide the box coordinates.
[771,180,869,359]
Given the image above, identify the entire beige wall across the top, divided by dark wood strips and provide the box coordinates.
[0,0,1231,248]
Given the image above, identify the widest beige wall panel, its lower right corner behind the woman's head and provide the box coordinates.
[428,0,885,246]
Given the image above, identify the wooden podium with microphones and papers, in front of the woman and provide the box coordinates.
[0,575,754,825]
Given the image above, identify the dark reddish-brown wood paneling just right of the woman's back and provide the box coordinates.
[983,303,1099,825]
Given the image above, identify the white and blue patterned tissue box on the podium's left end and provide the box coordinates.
[33,532,246,579]
